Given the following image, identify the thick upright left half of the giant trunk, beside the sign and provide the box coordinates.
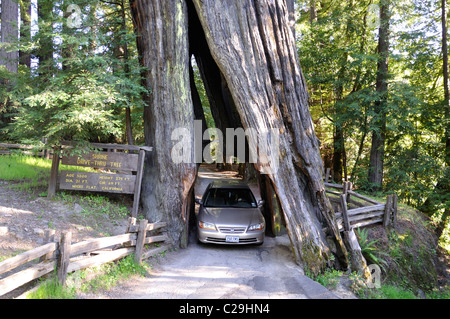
[130,0,197,246]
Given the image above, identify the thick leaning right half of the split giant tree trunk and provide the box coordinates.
[194,0,346,272]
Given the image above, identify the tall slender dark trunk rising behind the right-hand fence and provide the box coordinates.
[369,0,390,190]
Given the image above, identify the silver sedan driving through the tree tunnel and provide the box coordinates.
[196,181,266,244]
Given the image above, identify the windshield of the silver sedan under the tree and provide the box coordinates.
[203,188,257,208]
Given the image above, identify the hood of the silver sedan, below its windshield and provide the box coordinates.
[199,207,264,227]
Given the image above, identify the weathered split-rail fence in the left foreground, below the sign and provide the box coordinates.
[0,217,170,296]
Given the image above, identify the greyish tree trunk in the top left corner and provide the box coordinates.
[0,0,19,73]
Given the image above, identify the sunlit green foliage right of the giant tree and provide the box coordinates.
[297,0,450,242]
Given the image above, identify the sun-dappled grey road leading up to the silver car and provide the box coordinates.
[85,169,338,299]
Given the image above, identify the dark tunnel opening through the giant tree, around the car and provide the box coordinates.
[186,0,286,244]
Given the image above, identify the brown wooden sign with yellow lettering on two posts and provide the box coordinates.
[47,142,152,217]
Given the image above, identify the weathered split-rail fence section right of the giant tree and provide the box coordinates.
[325,182,397,231]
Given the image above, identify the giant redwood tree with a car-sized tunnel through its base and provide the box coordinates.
[130,0,347,272]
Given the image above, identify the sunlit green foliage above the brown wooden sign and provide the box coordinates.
[0,0,145,144]
